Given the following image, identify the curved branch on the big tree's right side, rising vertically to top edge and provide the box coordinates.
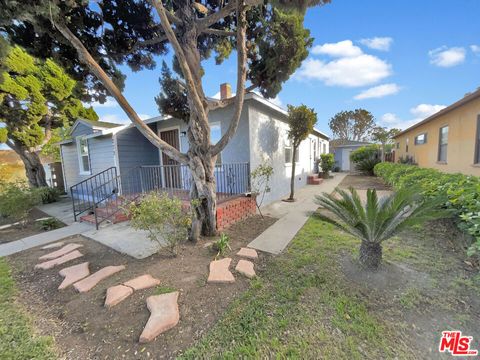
[211,0,247,156]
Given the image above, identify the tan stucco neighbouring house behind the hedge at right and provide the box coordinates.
[394,89,480,176]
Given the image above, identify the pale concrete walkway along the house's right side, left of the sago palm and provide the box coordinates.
[248,173,347,254]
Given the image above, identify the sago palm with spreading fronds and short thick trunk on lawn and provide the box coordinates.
[316,188,448,269]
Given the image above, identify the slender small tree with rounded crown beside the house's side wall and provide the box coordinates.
[288,105,317,201]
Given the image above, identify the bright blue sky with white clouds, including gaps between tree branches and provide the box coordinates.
[3,0,480,150]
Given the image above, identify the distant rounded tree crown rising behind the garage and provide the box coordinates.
[328,109,375,141]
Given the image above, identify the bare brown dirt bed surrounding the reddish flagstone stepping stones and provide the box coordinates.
[9,216,276,359]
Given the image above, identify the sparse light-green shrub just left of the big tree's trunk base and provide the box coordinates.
[128,193,191,256]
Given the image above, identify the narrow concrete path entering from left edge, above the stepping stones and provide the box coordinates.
[0,223,92,257]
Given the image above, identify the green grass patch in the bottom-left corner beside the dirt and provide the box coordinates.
[0,259,57,360]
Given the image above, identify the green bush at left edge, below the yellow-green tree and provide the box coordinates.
[0,182,42,222]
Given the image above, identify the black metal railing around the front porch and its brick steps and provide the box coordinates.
[70,163,250,229]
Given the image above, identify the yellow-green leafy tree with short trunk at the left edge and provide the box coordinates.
[0,46,98,187]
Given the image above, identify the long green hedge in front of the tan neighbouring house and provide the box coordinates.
[374,163,480,256]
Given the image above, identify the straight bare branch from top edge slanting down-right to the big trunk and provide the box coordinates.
[150,0,208,121]
